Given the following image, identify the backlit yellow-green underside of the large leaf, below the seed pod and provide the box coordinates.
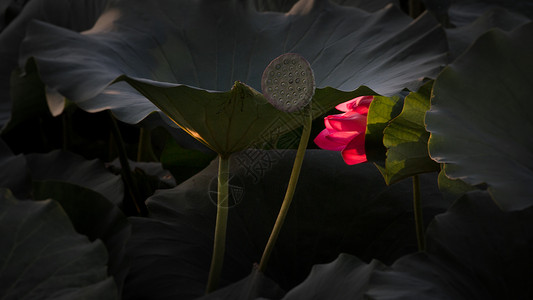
[119,77,368,155]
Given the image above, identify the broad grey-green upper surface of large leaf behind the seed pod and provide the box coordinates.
[22,0,447,123]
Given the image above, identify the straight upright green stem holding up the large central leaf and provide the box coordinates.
[206,155,229,294]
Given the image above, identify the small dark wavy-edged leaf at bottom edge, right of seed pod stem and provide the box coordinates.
[283,254,385,300]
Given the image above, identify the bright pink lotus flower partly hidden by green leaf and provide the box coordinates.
[315,96,374,165]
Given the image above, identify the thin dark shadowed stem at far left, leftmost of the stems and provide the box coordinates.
[109,112,148,216]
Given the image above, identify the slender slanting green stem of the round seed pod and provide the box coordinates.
[259,107,312,273]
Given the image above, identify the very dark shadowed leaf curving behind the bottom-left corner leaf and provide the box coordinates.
[33,180,131,298]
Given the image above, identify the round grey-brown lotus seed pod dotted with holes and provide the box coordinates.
[261,53,315,112]
